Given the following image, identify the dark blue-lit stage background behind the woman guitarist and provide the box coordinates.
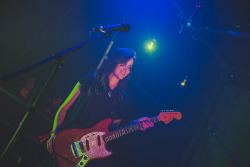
[0,0,250,167]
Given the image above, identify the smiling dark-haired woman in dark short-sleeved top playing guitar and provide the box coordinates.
[47,48,154,158]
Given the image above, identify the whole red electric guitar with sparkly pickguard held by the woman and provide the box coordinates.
[53,112,182,167]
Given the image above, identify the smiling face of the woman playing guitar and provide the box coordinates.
[113,58,134,80]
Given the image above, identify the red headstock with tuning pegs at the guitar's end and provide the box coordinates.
[159,110,182,124]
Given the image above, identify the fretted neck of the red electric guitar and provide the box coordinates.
[103,116,160,143]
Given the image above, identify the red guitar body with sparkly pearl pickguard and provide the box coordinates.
[53,119,112,167]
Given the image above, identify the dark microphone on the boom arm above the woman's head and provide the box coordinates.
[93,24,130,33]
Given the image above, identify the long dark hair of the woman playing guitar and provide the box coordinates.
[90,48,136,101]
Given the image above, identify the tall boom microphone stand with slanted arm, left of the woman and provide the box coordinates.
[0,30,112,166]
